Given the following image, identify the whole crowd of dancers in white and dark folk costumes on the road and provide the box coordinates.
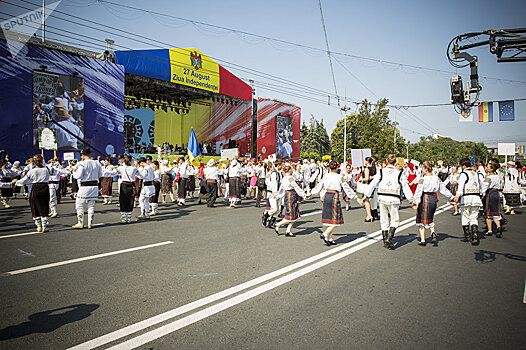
[0,149,526,249]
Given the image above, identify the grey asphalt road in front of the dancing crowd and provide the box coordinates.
[0,190,526,349]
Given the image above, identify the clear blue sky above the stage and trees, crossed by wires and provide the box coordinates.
[0,0,526,145]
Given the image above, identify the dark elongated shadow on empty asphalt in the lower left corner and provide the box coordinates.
[0,304,99,341]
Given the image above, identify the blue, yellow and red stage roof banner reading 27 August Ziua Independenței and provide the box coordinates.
[115,49,252,101]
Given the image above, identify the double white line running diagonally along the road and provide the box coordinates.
[69,203,451,350]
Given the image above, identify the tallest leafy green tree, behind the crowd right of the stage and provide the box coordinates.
[331,98,405,160]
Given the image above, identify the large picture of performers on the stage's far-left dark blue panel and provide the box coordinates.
[33,71,84,151]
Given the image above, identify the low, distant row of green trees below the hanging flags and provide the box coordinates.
[409,136,490,165]
